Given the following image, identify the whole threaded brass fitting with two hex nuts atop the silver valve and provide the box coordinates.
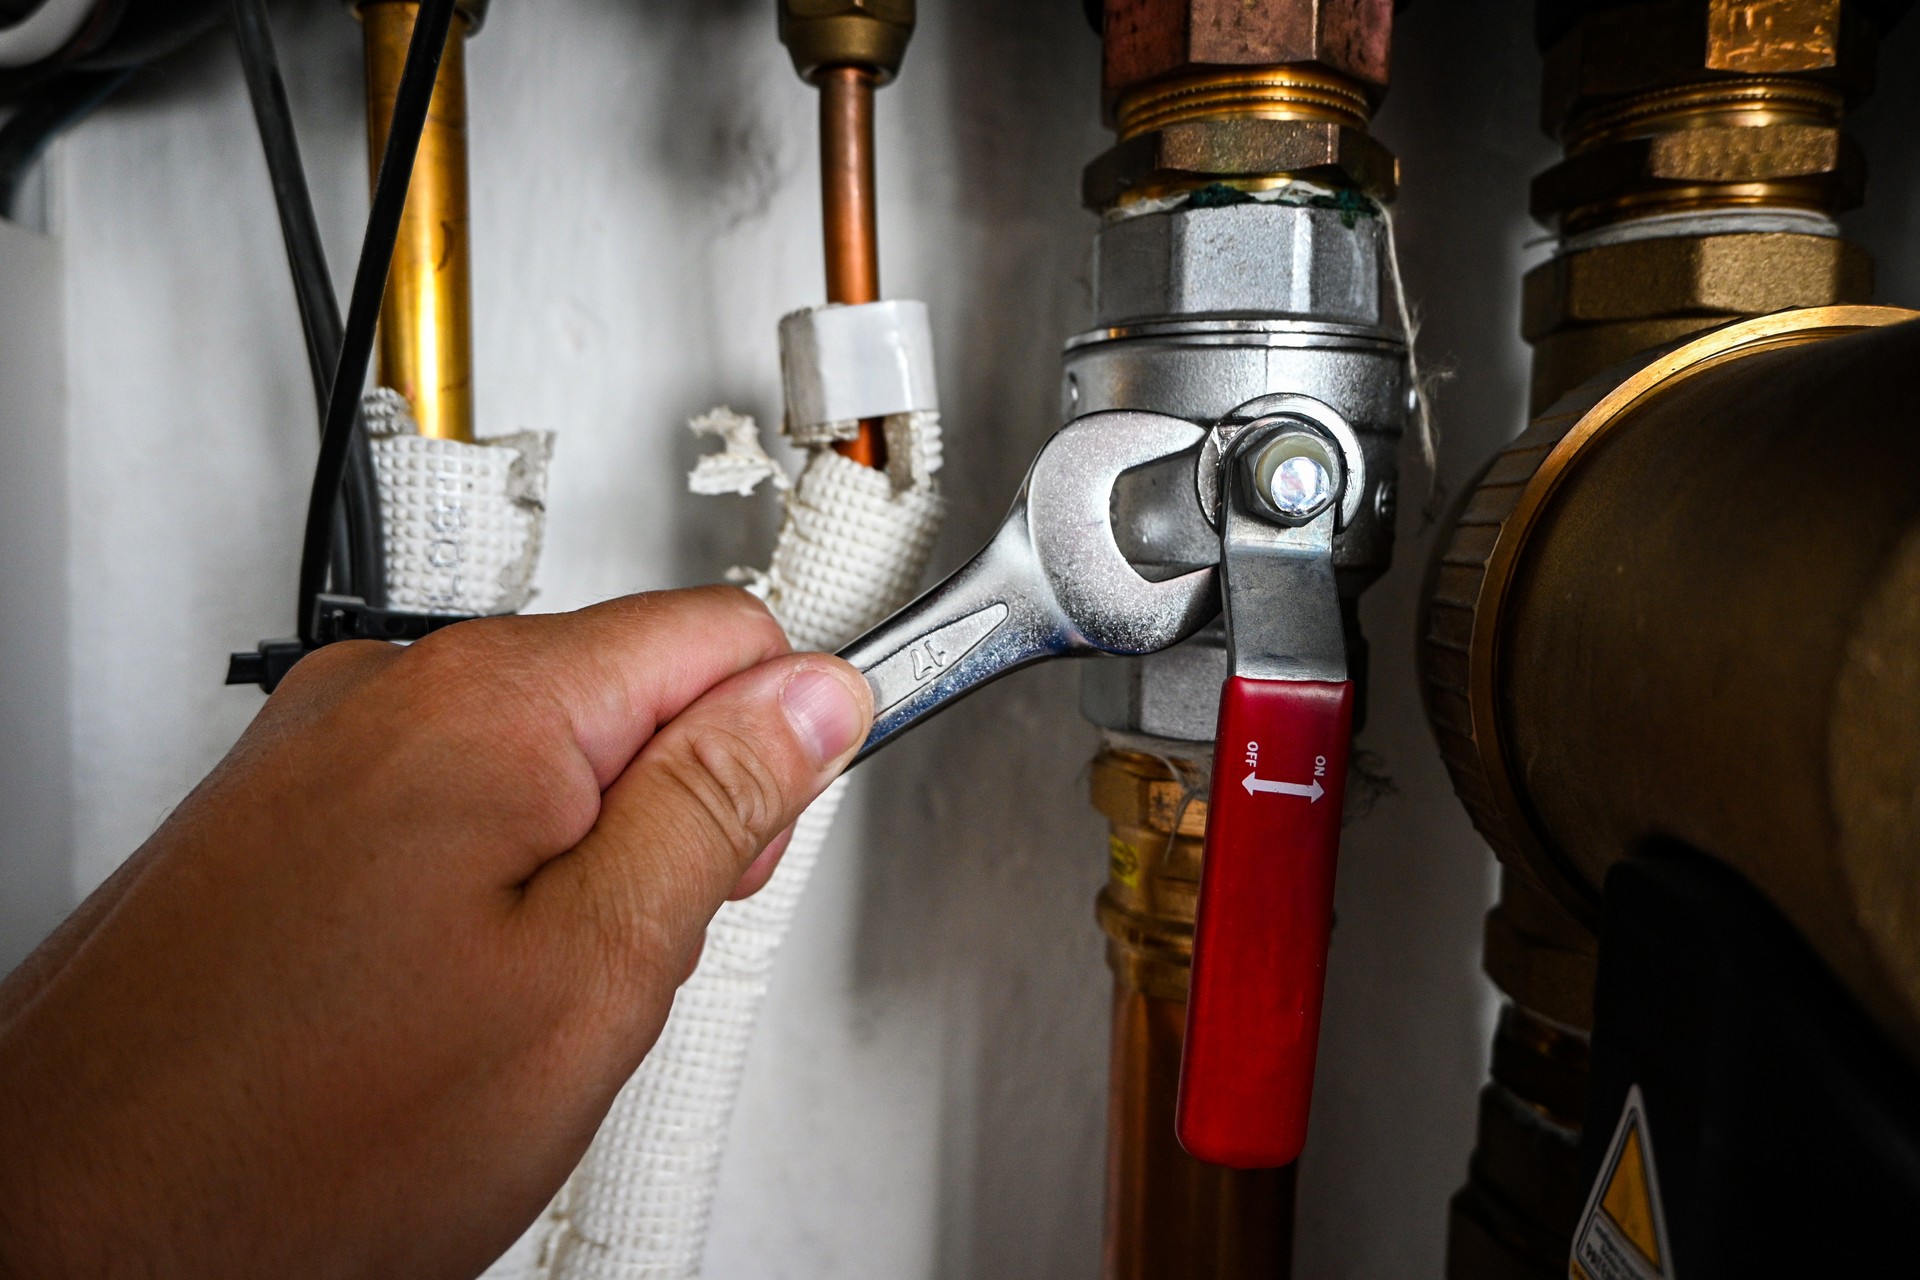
[1081,0,1398,209]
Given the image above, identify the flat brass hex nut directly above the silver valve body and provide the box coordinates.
[1081,119,1400,209]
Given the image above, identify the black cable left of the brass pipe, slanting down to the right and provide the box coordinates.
[232,0,386,608]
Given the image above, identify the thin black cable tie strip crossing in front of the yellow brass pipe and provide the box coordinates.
[296,0,455,645]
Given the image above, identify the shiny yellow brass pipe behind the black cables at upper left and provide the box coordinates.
[361,0,474,441]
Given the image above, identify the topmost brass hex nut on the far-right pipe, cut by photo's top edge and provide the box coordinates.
[1542,0,1880,136]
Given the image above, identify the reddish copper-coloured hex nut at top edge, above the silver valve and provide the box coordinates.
[1102,0,1394,119]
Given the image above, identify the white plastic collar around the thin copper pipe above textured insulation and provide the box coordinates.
[780,299,941,439]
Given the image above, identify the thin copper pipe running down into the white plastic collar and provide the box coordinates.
[816,67,887,466]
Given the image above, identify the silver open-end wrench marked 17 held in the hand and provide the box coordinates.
[839,413,1219,760]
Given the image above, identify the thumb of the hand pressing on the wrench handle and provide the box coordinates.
[528,654,874,998]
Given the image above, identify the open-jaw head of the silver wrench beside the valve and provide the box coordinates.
[1025,411,1219,654]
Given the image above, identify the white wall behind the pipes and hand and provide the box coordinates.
[22,0,1920,1280]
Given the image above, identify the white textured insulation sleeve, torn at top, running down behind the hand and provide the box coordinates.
[488,395,945,1280]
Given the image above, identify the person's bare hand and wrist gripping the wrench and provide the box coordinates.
[0,589,872,1280]
